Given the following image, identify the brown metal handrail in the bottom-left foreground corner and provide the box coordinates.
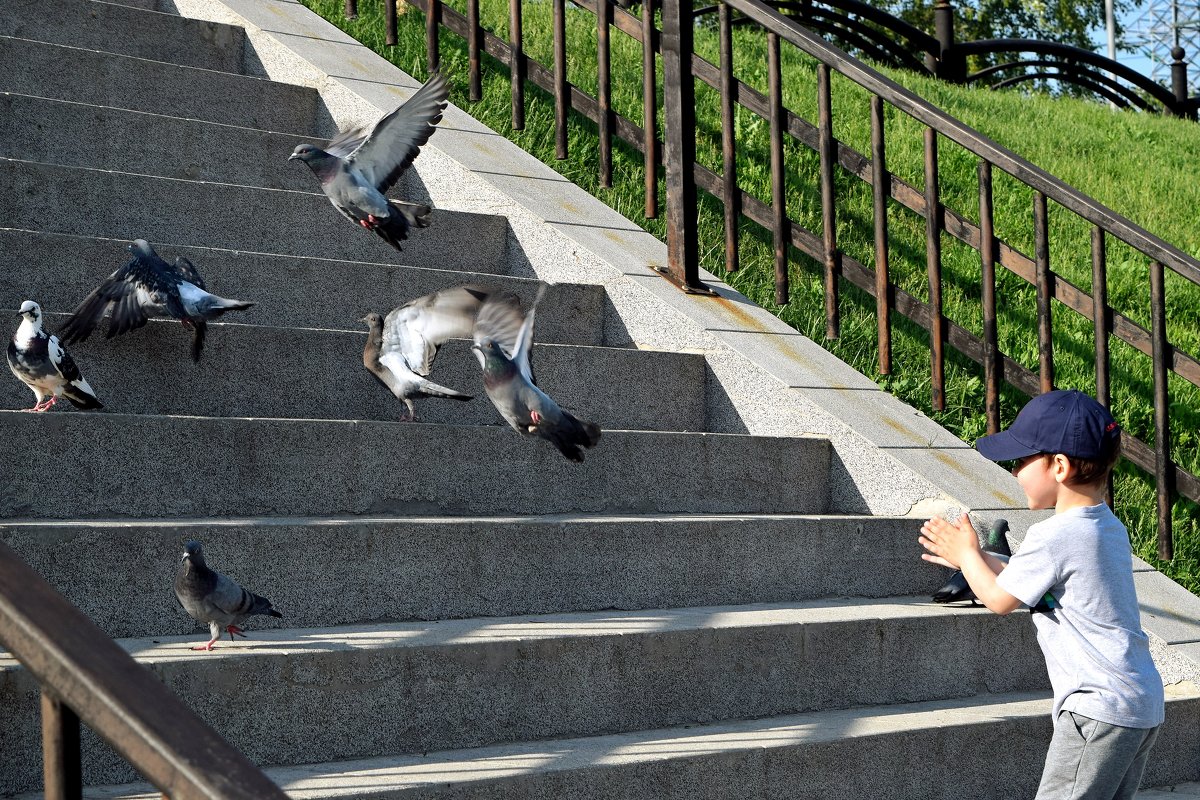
[0,542,287,800]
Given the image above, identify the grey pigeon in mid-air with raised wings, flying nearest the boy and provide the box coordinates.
[472,284,600,462]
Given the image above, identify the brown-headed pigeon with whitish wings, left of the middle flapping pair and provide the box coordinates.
[362,285,496,420]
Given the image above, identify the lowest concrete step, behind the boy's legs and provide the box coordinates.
[28,685,1200,800]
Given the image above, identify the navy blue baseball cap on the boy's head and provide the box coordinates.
[976,389,1121,461]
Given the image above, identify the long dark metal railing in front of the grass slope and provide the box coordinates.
[350,0,1200,560]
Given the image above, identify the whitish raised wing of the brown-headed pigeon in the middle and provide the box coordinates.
[380,284,496,375]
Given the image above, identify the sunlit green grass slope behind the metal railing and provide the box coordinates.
[302,0,1200,594]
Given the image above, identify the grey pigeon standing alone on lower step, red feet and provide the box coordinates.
[175,539,283,650]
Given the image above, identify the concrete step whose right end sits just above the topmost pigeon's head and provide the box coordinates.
[0,36,318,134]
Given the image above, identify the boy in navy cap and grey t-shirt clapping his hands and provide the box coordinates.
[919,390,1164,800]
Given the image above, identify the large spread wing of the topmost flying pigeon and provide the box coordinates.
[348,74,450,192]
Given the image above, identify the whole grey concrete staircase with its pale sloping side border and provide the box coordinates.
[0,0,1200,800]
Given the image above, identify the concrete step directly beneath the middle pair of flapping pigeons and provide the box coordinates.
[0,411,830,519]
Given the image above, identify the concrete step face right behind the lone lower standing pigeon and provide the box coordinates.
[0,515,948,637]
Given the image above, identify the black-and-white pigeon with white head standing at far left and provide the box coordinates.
[8,300,104,411]
